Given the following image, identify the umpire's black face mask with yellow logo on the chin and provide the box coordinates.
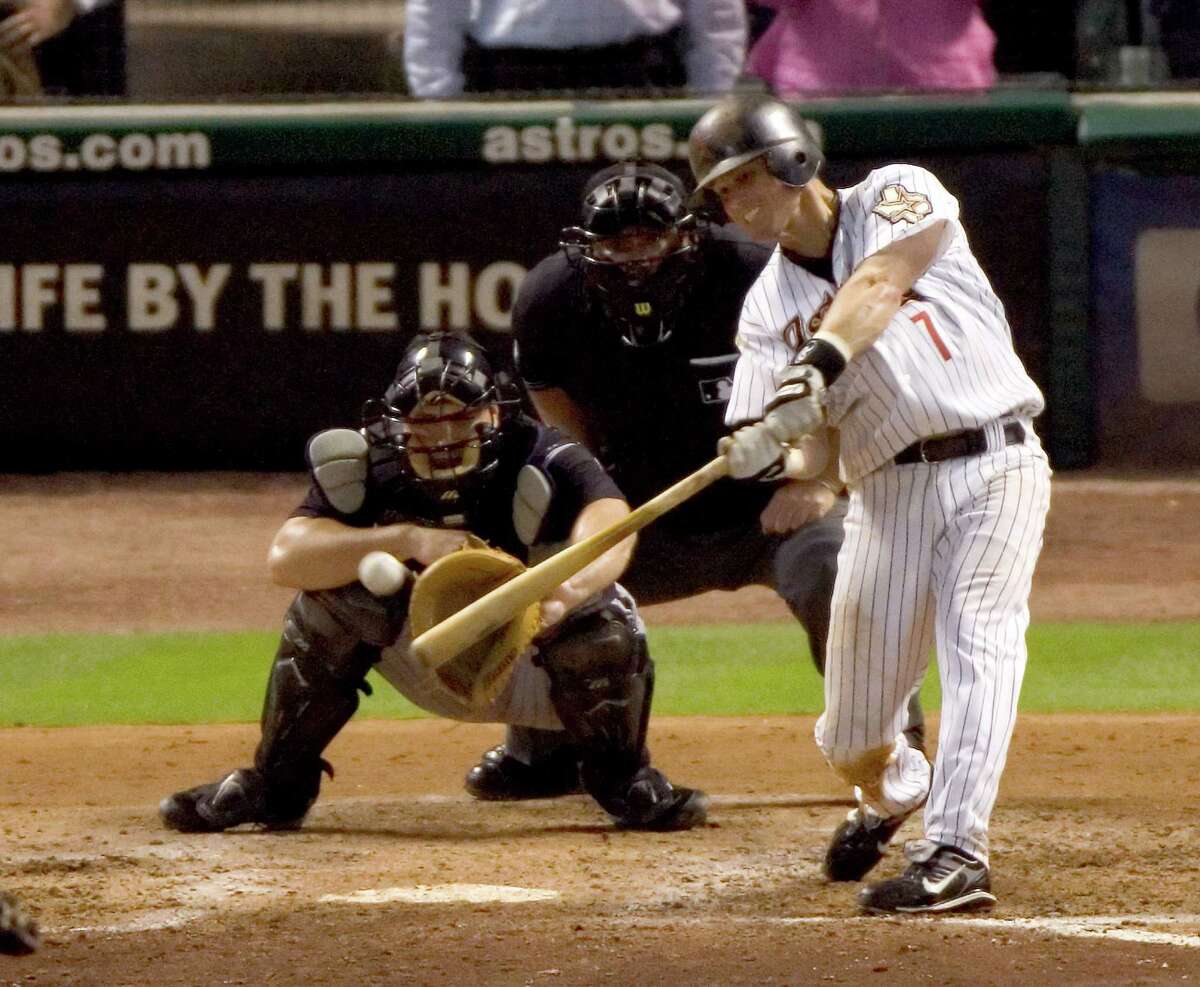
[559,161,703,346]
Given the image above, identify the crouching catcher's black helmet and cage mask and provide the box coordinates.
[362,333,518,497]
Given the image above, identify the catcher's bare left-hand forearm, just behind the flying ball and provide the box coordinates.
[268,518,467,590]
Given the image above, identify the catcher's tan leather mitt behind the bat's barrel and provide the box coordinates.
[408,548,540,706]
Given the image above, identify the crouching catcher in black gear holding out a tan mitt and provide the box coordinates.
[158,333,708,832]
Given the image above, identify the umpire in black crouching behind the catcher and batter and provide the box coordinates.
[466,162,923,800]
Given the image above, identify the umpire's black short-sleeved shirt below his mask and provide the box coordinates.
[512,228,773,531]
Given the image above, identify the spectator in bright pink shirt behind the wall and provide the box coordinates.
[746,0,996,95]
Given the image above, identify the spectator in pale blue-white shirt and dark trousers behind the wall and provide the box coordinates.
[403,0,746,100]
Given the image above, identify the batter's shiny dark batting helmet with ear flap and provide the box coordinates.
[688,95,823,192]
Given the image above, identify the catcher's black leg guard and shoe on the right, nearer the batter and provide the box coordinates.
[539,608,708,830]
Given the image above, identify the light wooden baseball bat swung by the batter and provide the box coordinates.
[413,456,730,668]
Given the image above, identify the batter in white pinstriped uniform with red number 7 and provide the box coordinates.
[690,97,1050,913]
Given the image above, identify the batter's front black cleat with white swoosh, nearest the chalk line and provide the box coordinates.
[858,839,996,915]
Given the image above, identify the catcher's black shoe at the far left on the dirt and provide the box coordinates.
[158,761,332,833]
